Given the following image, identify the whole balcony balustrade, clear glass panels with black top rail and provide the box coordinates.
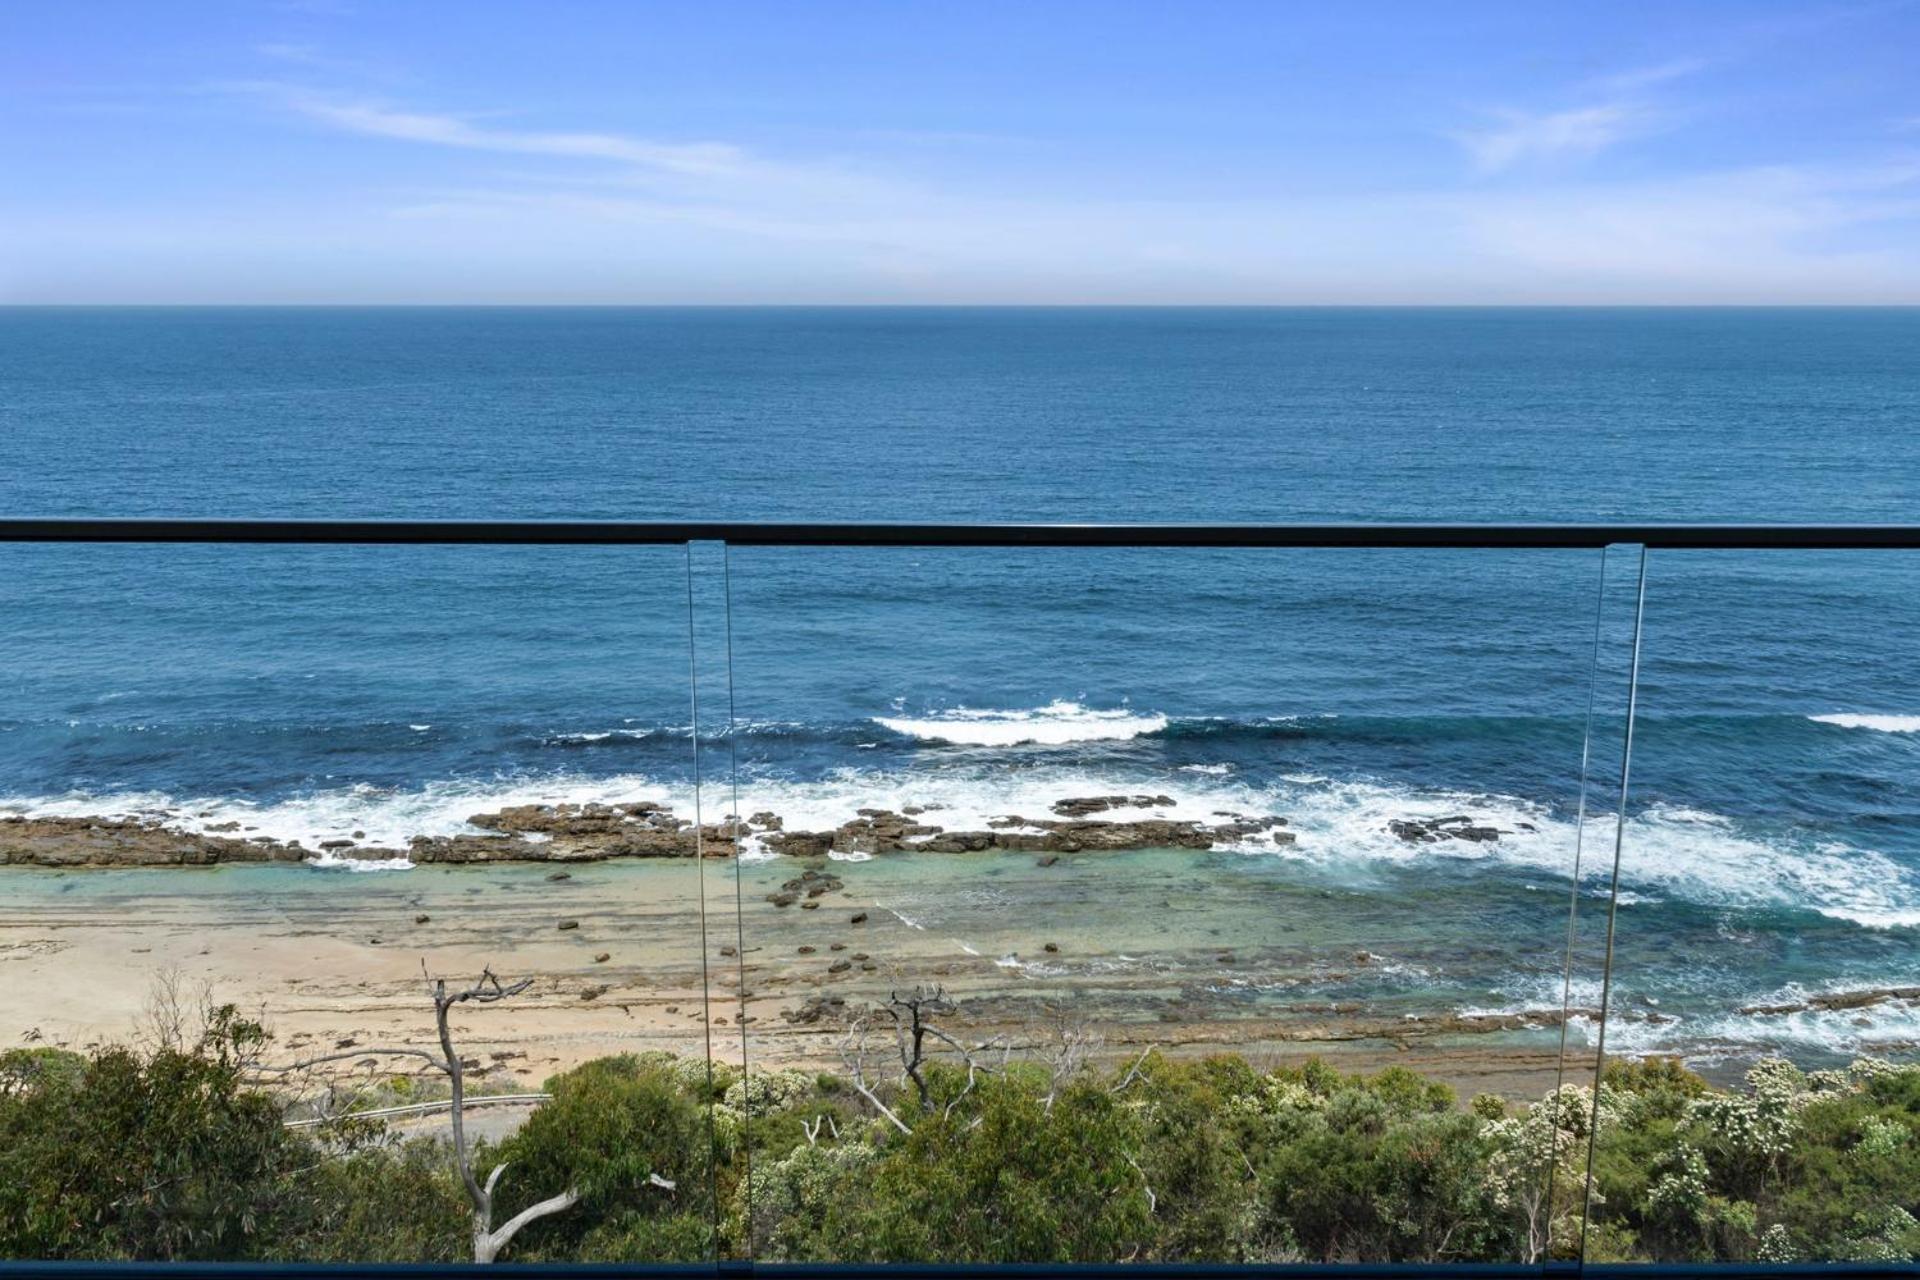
[0,518,1920,1276]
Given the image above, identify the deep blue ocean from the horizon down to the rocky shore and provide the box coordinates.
[0,309,1920,1059]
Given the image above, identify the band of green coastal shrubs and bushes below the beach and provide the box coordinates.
[0,975,1920,1261]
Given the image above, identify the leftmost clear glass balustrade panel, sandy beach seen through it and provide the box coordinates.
[0,545,714,1261]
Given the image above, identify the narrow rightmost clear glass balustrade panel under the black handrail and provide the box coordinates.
[1586,551,1920,1263]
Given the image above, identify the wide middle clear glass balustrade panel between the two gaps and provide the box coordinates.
[732,547,1619,1261]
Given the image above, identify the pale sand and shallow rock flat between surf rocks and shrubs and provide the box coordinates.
[0,852,1592,1096]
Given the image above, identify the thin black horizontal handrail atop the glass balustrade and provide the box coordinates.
[0,516,1920,551]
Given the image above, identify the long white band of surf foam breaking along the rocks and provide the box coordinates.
[11,758,1920,929]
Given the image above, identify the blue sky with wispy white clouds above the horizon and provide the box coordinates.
[0,0,1920,303]
